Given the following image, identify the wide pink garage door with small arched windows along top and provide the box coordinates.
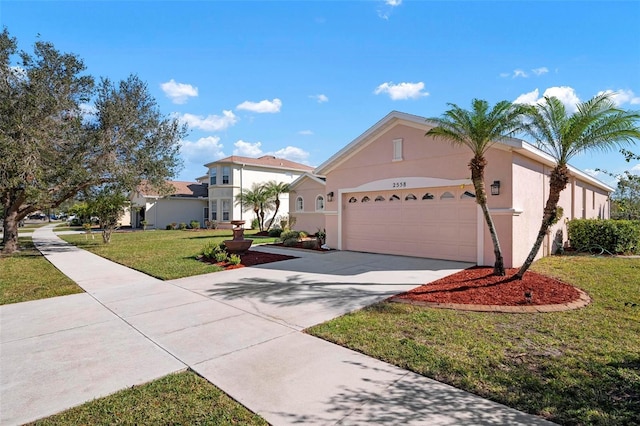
[342,187,477,262]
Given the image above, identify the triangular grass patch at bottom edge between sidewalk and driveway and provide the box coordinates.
[30,371,267,426]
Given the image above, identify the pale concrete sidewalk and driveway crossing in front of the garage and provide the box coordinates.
[0,227,548,425]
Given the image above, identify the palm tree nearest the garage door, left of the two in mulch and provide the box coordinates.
[425,99,522,276]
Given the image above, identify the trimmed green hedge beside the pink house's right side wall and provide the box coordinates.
[568,219,640,254]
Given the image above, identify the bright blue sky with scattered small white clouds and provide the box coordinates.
[0,0,640,185]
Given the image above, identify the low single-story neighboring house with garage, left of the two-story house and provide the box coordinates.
[130,181,209,229]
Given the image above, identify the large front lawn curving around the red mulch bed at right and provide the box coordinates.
[308,256,640,425]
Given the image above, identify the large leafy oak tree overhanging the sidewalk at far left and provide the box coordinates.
[0,28,186,253]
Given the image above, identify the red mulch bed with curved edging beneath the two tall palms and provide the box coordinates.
[396,267,580,306]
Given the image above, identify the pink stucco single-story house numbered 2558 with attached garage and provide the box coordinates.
[289,111,613,267]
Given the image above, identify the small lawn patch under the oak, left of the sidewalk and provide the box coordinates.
[0,237,82,305]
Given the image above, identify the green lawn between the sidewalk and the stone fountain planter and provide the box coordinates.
[60,229,278,280]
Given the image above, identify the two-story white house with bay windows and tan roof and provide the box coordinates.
[204,155,313,228]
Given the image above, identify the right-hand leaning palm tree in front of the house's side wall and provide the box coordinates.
[513,93,640,279]
